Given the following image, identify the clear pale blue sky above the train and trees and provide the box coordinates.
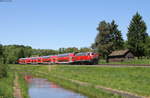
[0,0,150,49]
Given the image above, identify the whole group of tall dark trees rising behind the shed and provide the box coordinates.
[91,12,150,59]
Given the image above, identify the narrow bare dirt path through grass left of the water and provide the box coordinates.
[13,73,22,98]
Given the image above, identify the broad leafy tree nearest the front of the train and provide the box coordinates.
[92,21,113,58]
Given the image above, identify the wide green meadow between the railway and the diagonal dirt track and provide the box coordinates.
[11,65,150,98]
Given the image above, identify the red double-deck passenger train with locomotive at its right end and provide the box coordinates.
[18,52,100,65]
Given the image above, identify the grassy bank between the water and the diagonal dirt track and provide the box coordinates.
[11,65,121,98]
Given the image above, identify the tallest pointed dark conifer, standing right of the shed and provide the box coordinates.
[127,12,148,57]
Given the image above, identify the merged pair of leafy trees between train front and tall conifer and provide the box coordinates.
[92,20,124,58]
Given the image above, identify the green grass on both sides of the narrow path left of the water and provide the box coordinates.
[0,66,29,98]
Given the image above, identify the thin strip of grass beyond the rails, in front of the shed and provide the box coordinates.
[99,59,150,64]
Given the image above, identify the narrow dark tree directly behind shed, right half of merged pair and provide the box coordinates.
[110,20,124,50]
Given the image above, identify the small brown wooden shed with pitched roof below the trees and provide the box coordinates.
[108,49,134,62]
